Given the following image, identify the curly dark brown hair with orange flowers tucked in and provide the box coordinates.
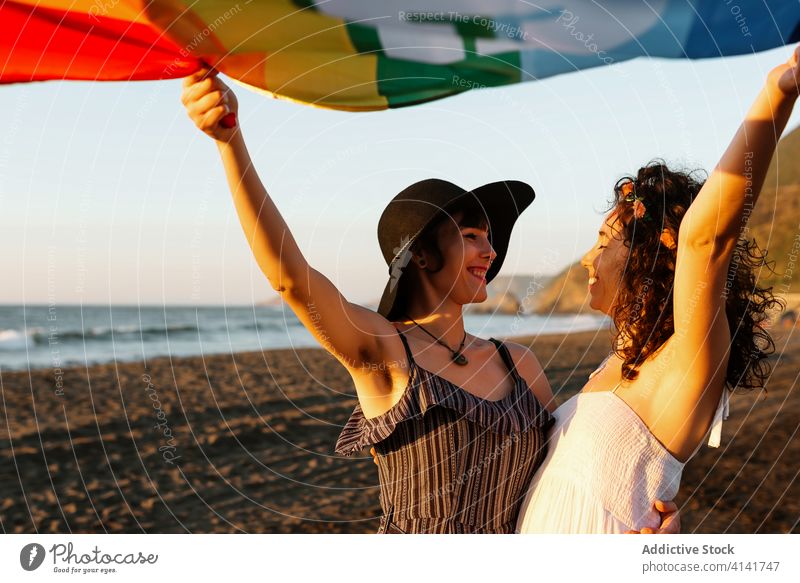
[608,160,782,389]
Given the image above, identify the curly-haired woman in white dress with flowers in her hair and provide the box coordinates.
[517,47,800,533]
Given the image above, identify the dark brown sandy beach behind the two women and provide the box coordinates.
[0,332,800,533]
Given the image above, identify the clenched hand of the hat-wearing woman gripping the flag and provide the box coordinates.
[181,68,239,142]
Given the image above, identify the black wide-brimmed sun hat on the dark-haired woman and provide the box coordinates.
[378,178,536,318]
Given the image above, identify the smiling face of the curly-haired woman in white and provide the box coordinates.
[581,212,629,316]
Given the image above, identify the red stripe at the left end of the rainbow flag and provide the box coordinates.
[0,0,200,83]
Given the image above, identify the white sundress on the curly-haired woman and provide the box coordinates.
[515,358,729,534]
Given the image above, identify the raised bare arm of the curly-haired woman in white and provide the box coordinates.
[671,48,800,442]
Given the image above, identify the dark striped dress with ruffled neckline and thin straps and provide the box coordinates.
[336,333,554,533]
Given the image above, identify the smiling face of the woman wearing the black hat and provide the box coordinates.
[419,206,497,305]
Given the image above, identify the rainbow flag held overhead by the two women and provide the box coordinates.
[0,0,800,111]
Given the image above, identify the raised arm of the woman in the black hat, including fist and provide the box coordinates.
[181,71,394,371]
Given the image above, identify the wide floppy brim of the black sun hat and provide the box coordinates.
[378,180,536,319]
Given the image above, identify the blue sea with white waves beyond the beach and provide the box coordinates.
[0,304,608,372]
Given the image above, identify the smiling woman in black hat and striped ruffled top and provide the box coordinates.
[182,67,675,533]
